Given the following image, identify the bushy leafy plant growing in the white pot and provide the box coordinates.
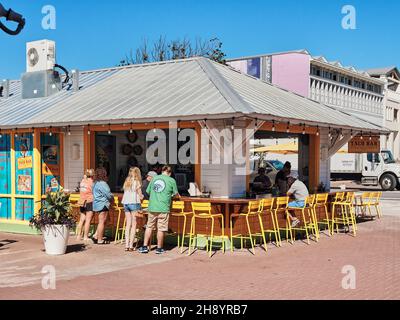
[29,190,75,230]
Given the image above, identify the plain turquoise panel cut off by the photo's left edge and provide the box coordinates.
[0,134,11,219]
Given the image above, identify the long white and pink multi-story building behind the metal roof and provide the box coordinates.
[228,50,385,125]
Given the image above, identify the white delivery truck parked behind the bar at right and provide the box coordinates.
[331,150,400,191]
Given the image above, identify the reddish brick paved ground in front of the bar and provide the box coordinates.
[0,212,400,300]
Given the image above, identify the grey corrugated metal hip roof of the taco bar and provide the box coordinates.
[0,58,385,132]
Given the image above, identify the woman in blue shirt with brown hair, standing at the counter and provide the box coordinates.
[92,168,113,244]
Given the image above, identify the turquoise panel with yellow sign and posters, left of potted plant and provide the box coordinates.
[14,133,34,221]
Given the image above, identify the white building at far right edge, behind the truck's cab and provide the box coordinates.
[368,67,400,161]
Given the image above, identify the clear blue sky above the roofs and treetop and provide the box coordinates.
[0,0,400,79]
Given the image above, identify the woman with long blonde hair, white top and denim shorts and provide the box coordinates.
[122,167,143,251]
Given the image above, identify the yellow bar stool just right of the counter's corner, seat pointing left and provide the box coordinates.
[230,201,267,254]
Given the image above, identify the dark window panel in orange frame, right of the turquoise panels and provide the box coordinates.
[40,133,61,194]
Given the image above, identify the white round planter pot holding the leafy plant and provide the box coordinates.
[42,224,69,255]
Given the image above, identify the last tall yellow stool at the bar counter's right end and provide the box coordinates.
[332,192,357,236]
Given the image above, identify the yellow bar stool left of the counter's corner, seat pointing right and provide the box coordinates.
[188,202,225,257]
